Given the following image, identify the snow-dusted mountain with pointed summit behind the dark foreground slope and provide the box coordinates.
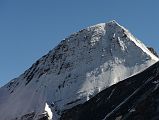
[0,21,158,120]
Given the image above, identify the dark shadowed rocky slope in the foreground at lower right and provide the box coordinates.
[61,62,159,120]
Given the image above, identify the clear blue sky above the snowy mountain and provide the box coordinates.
[0,0,159,86]
